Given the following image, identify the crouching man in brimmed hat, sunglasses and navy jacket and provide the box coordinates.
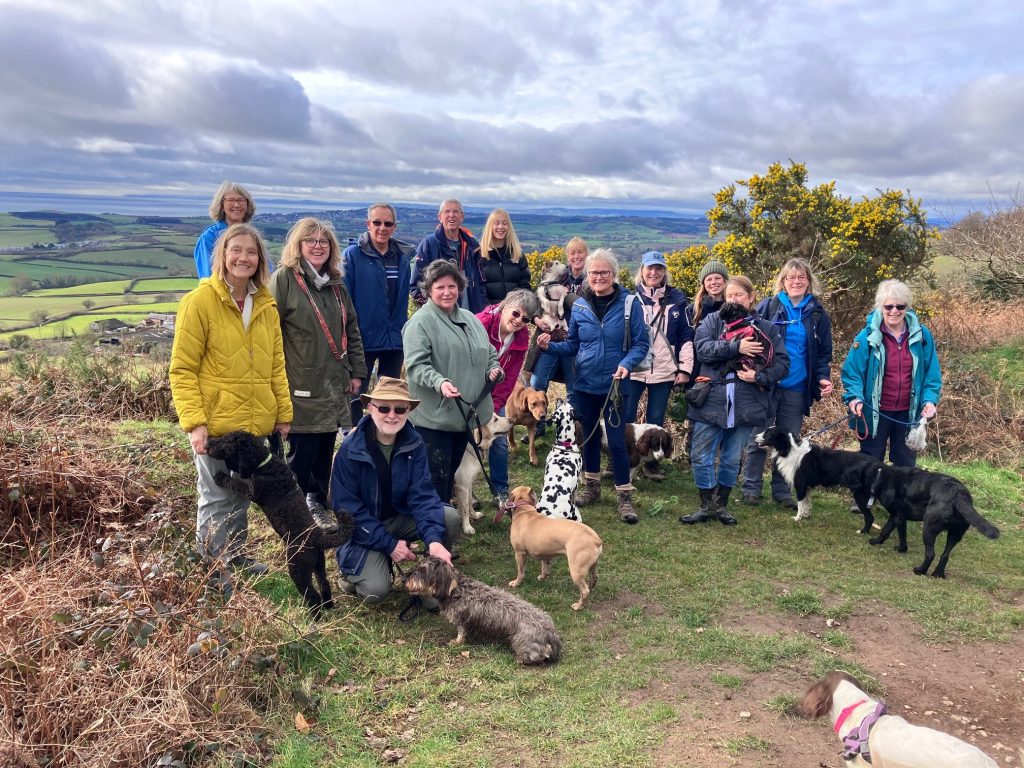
[331,376,461,608]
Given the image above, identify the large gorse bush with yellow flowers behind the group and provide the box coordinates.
[708,162,938,328]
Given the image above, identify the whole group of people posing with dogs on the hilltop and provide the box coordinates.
[170,182,941,600]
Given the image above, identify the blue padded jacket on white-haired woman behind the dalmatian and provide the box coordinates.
[548,285,650,394]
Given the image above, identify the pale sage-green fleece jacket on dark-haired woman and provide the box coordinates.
[401,300,498,432]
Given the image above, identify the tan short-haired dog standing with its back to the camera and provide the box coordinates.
[508,485,604,610]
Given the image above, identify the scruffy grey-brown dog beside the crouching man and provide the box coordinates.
[406,557,562,665]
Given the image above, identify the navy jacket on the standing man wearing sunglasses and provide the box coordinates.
[342,232,413,352]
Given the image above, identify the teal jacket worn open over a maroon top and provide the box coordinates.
[843,310,942,435]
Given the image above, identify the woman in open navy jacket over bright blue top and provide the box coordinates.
[743,259,833,509]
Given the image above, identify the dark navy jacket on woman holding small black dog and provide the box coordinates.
[686,312,790,429]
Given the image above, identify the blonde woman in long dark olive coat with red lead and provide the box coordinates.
[270,217,367,530]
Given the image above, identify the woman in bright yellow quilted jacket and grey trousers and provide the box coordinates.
[170,224,292,574]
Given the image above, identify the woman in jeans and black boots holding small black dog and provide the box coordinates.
[679,274,790,525]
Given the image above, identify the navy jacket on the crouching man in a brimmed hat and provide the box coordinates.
[331,415,444,574]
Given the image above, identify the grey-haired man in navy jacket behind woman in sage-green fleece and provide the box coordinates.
[412,199,487,314]
